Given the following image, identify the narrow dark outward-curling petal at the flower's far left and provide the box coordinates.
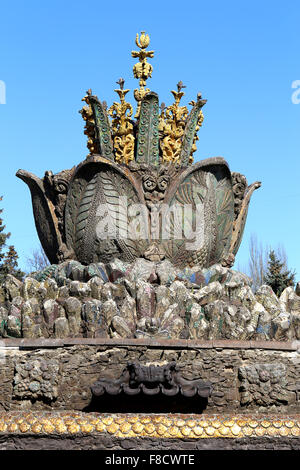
[16,170,62,264]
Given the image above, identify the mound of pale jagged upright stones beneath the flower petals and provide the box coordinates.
[0,259,300,341]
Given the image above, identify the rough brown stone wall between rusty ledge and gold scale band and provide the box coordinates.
[0,339,300,413]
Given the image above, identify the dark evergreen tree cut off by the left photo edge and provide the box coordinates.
[0,197,24,284]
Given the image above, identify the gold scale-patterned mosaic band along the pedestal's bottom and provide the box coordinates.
[0,411,300,439]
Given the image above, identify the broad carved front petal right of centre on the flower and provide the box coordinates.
[162,157,234,267]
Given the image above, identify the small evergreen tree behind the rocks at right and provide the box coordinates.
[264,250,295,297]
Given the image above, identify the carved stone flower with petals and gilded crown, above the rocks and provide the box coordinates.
[17,32,260,267]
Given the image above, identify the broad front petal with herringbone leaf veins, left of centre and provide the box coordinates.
[65,156,147,264]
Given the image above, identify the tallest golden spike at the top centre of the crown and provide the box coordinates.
[131,31,154,118]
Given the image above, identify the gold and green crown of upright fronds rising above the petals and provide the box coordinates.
[80,32,206,167]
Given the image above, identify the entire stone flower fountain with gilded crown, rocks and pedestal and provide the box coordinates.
[0,33,300,452]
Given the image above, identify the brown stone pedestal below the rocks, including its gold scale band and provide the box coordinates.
[0,338,300,450]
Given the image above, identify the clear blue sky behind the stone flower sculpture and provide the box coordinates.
[0,0,300,280]
